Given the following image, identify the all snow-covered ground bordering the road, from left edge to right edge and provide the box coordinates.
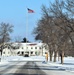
[0,56,74,72]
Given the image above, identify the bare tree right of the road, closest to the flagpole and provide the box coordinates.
[34,6,54,61]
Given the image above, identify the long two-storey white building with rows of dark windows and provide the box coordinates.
[2,43,48,56]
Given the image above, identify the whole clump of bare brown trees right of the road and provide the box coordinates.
[34,0,74,64]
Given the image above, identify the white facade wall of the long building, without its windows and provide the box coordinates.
[2,43,48,56]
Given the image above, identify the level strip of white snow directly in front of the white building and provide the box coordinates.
[2,56,46,61]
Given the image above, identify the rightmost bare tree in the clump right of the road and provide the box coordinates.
[49,0,74,64]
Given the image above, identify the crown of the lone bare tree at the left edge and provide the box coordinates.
[0,22,13,43]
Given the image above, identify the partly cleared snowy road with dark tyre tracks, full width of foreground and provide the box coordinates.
[0,61,74,75]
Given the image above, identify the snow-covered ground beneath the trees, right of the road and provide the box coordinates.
[49,57,74,72]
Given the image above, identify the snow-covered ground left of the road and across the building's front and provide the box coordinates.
[0,56,46,67]
